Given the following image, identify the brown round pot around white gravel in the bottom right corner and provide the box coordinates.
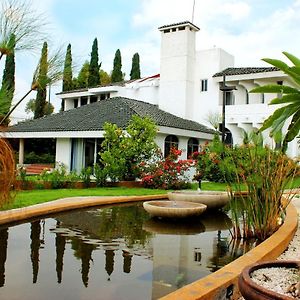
[238,260,300,300]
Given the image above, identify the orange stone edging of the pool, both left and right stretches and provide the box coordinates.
[0,194,298,300]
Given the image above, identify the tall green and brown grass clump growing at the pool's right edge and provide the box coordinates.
[223,144,299,240]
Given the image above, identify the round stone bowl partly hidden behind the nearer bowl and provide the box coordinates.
[168,191,229,209]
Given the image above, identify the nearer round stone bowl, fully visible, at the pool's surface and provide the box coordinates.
[143,200,206,218]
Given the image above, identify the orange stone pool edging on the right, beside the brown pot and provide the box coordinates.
[160,204,298,300]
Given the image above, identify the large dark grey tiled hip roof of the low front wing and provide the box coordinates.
[7,97,214,134]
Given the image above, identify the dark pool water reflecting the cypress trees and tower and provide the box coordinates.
[0,203,253,300]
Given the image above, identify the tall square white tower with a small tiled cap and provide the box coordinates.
[158,21,199,118]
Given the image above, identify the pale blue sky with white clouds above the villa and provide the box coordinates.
[0,0,300,122]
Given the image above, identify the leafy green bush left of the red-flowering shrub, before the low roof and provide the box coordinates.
[100,115,157,181]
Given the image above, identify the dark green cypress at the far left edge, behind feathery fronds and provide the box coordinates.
[0,35,15,115]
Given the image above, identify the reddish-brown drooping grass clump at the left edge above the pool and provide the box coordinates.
[0,137,16,208]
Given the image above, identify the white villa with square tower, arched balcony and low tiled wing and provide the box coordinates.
[3,21,299,170]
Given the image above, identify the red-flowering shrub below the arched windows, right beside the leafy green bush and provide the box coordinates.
[139,148,194,189]
